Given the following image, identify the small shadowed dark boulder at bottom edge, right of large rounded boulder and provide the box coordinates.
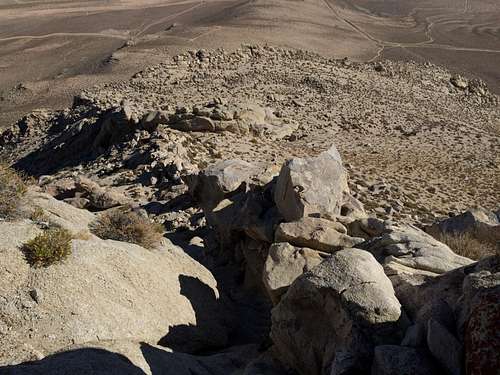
[371,345,441,375]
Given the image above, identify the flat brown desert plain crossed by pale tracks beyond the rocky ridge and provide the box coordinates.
[0,0,500,127]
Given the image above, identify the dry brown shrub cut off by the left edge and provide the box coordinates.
[0,163,27,218]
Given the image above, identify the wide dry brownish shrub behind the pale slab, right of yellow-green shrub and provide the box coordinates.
[91,210,163,249]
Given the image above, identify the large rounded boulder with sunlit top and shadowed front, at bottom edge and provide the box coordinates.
[271,249,408,375]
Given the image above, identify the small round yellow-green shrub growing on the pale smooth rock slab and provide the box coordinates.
[23,228,73,267]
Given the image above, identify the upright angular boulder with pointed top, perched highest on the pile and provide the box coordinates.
[274,146,349,221]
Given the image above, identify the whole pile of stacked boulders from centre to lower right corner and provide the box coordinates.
[185,146,500,375]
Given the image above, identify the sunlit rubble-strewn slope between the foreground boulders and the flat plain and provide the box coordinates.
[0,47,500,223]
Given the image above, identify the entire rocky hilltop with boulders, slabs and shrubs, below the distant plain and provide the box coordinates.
[0,45,500,375]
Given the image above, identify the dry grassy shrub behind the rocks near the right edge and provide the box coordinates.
[435,232,495,260]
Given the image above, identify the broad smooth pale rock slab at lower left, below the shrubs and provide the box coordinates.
[0,196,227,364]
